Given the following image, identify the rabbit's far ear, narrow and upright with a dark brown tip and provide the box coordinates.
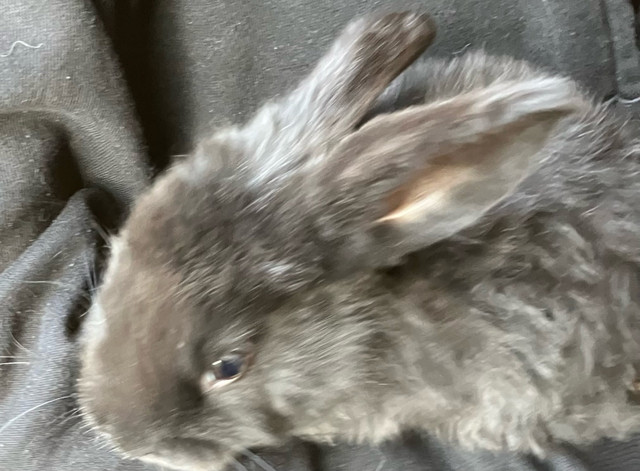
[215,12,435,187]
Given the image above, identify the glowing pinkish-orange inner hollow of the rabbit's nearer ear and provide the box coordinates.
[377,156,474,222]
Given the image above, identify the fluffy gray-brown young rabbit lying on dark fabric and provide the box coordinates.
[78,11,640,471]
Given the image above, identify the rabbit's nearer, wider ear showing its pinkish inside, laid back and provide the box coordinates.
[313,78,583,265]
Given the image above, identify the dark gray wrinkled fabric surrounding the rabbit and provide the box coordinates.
[0,0,640,471]
